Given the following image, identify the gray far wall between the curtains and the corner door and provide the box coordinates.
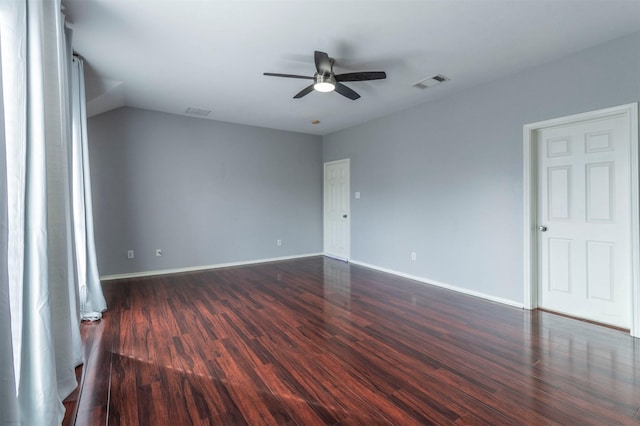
[88,108,322,276]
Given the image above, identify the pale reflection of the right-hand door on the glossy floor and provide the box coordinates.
[523,311,640,411]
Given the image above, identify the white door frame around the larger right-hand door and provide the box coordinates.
[523,102,640,337]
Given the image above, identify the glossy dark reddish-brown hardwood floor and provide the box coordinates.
[67,257,640,425]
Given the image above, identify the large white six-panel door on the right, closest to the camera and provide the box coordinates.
[536,116,631,328]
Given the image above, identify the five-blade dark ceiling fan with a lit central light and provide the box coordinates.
[264,50,387,101]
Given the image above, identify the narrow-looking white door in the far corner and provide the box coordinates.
[324,159,350,260]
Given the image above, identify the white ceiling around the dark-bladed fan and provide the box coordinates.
[62,0,640,135]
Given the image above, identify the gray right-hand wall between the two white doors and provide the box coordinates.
[323,33,640,303]
